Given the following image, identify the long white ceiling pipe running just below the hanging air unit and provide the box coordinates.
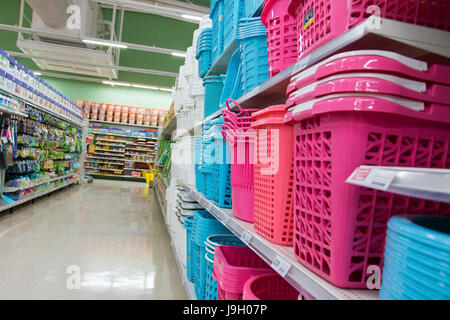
[7,51,178,78]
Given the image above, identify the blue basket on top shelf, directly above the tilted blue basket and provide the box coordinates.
[223,0,245,49]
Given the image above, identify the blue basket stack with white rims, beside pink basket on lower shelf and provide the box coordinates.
[201,235,245,300]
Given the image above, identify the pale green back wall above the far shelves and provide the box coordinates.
[42,77,172,110]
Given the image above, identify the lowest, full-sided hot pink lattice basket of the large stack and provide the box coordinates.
[286,96,450,288]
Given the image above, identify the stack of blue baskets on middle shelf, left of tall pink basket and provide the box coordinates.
[200,117,231,208]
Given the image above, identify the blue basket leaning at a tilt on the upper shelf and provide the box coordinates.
[220,49,242,107]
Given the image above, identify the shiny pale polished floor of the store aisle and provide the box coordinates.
[0,180,187,299]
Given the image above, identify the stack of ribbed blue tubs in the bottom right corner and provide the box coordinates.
[380,216,450,300]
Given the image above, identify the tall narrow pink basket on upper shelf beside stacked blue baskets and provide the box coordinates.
[261,0,298,77]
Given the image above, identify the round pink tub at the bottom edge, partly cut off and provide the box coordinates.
[242,273,300,300]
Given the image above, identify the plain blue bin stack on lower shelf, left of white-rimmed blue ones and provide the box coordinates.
[191,210,230,300]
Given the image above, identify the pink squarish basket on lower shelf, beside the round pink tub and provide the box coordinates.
[213,246,273,300]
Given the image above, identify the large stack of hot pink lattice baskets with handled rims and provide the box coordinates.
[285,50,450,288]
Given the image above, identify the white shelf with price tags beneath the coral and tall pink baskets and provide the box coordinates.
[178,181,378,300]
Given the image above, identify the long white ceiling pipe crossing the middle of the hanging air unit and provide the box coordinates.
[0,24,186,55]
